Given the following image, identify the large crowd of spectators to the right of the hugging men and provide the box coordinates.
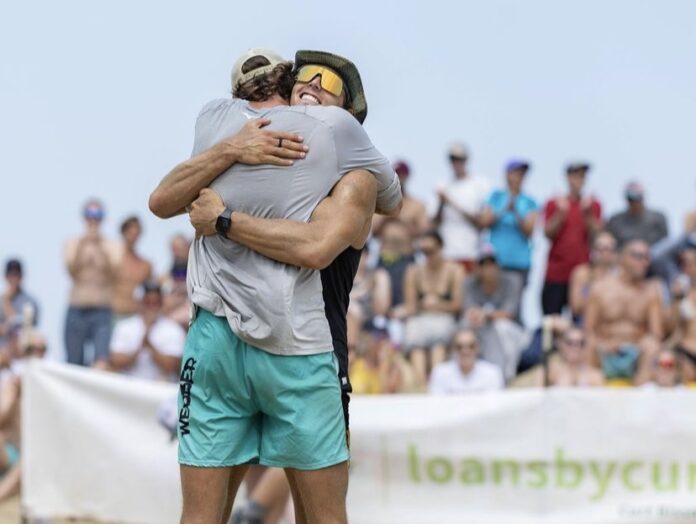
[349,141,696,394]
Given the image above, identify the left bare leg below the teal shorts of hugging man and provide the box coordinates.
[180,466,246,524]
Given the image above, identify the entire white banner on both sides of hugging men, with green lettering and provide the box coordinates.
[22,362,696,524]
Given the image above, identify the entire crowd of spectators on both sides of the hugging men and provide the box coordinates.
[0,145,696,500]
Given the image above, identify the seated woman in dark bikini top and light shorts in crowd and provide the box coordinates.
[404,231,464,388]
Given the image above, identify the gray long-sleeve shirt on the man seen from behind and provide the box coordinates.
[188,99,401,355]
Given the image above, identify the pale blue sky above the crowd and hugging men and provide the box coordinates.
[0,0,696,354]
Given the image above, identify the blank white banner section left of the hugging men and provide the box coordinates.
[22,361,181,524]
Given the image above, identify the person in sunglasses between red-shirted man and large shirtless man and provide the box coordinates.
[569,231,616,324]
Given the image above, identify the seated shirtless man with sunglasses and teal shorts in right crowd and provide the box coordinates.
[585,240,663,384]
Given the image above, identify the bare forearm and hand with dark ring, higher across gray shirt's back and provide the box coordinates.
[149,118,307,218]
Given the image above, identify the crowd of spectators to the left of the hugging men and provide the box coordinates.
[0,199,190,501]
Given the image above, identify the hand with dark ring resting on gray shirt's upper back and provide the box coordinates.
[224,118,309,166]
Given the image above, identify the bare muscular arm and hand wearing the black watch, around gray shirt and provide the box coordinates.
[190,170,377,269]
